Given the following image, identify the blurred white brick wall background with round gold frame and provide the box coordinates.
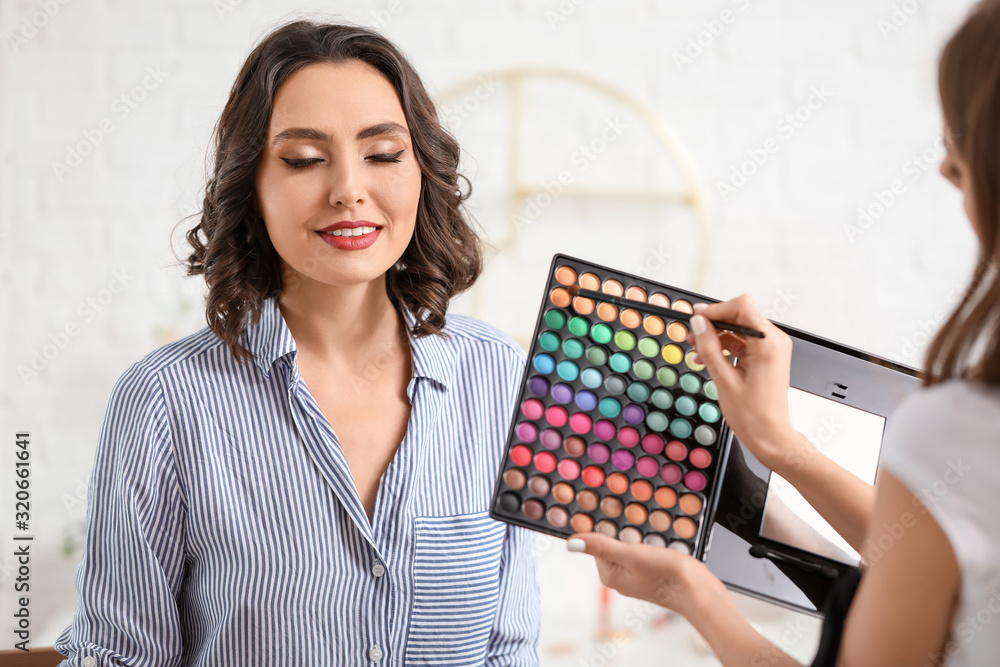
[0,0,975,665]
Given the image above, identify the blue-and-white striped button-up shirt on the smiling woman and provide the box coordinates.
[55,298,539,667]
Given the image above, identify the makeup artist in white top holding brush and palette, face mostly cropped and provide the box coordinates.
[567,0,1000,667]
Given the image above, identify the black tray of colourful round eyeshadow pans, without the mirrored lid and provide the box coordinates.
[491,255,725,555]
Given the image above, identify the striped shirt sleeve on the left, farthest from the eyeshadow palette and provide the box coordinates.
[55,362,185,667]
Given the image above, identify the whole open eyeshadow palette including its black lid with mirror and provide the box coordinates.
[490,255,920,615]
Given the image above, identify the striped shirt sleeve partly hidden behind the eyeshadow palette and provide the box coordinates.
[485,342,541,667]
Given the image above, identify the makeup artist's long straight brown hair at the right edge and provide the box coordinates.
[924,0,1000,385]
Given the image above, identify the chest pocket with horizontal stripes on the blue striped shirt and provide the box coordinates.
[406,512,506,665]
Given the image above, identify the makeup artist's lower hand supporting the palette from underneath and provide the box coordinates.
[566,533,732,618]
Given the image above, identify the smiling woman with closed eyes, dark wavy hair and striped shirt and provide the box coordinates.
[56,21,539,666]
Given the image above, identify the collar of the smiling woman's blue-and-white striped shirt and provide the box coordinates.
[246,296,456,389]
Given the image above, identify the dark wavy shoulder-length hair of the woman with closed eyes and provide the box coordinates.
[186,20,482,361]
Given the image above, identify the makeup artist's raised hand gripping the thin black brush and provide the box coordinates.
[688,294,804,472]
